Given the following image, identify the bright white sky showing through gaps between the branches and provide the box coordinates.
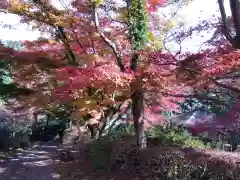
[0,0,230,51]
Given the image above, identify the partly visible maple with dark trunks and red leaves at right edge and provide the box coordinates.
[178,0,240,133]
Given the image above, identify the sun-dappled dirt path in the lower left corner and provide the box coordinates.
[0,142,64,180]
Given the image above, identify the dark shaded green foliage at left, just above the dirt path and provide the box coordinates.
[0,111,68,151]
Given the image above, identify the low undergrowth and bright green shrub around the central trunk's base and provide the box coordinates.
[56,127,240,180]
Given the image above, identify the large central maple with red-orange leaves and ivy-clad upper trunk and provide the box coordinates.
[0,0,239,147]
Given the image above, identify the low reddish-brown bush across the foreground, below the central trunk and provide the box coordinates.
[58,134,240,180]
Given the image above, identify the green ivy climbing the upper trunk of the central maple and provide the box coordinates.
[129,0,149,50]
